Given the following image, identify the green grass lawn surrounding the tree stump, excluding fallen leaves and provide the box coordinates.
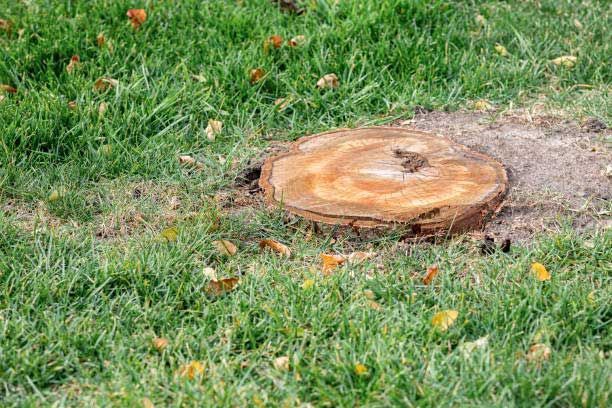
[0,0,612,407]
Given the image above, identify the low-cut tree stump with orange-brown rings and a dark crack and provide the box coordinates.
[259,127,508,235]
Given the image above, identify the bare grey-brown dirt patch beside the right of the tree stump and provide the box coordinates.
[394,111,612,242]
